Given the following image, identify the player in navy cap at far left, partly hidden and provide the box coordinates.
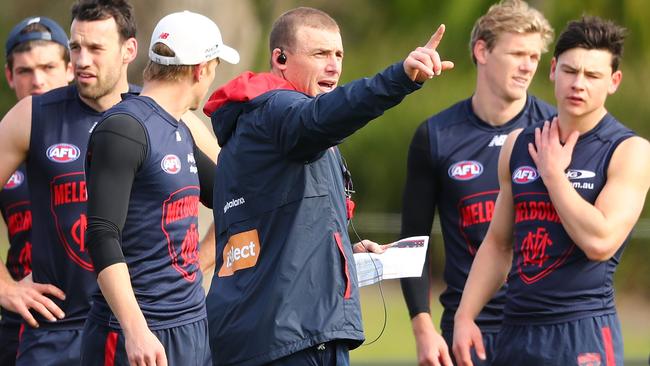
[0,17,73,366]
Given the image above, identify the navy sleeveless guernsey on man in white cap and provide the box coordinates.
[89,96,206,330]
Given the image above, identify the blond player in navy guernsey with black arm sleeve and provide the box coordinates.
[401,0,556,366]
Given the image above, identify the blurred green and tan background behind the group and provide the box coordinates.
[0,0,650,365]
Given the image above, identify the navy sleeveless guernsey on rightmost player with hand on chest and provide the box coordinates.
[504,114,634,324]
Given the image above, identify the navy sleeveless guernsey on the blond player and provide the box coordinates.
[427,96,556,331]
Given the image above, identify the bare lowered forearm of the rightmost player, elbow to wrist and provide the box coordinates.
[456,239,512,320]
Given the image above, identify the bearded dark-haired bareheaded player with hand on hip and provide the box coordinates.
[0,0,137,365]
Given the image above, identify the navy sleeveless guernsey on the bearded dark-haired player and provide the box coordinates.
[27,85,101,328]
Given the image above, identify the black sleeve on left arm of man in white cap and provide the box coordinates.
[86,114,147,274]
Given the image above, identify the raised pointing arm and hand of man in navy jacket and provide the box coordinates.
[273,25,454,161]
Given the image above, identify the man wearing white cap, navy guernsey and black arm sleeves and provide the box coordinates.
[82,11,239,365]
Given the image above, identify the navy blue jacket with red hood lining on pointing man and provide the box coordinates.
[206,63,419,365]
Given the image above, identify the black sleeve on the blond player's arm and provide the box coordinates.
[401,122,436,318]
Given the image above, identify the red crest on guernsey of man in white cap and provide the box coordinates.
[162,186,200,282]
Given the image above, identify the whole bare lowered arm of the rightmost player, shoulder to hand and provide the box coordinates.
[453,130,521,365]
